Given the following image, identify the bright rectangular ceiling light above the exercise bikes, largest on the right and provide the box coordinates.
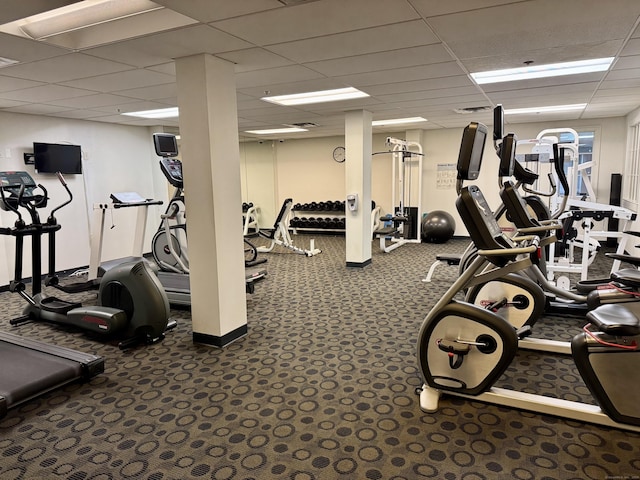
[471,57,614,85]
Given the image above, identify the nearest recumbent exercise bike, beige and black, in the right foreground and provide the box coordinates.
[417,123,640,431]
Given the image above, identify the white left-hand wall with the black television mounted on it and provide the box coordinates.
[0,112,167,285]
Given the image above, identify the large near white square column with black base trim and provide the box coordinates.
[176,54,247,347]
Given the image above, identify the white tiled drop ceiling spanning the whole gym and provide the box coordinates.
[0,0,640,139]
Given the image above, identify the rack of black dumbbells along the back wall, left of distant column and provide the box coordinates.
[289,200,346,233]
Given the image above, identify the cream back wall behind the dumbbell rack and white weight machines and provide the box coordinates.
[239,117,626,235]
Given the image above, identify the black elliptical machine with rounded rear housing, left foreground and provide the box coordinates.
[0,172,176,350]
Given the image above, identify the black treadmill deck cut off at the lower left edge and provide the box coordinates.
[0,332,104,418]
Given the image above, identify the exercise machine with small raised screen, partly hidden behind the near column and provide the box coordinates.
[151,133,267,306]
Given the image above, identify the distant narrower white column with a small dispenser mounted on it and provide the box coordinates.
[345,110,372,267]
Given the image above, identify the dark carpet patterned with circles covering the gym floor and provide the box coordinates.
[0,236,640,480]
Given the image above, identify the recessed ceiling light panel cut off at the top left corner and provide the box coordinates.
[14,0,164,40]
